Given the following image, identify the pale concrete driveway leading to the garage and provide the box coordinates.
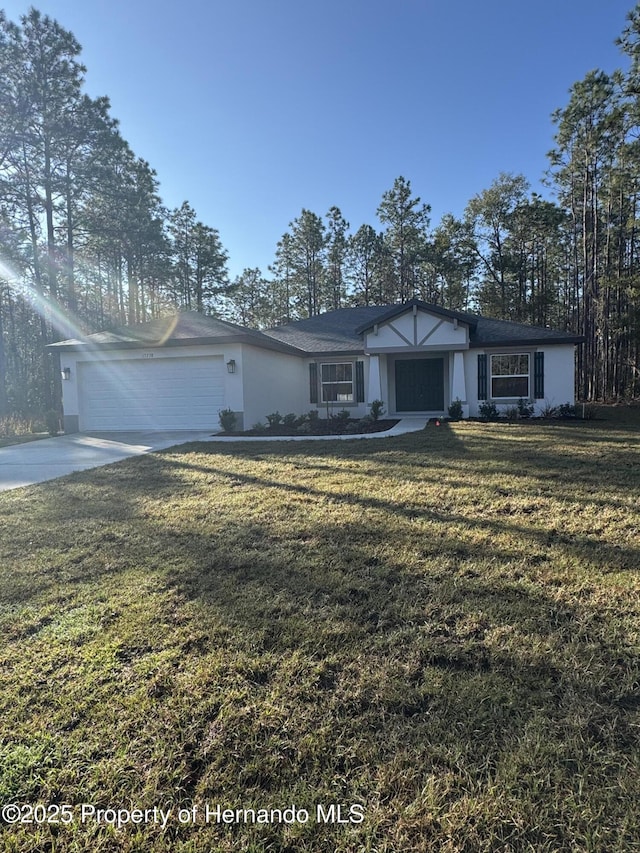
[0,431,211,491]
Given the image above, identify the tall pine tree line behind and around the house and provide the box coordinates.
[0,4,640,417]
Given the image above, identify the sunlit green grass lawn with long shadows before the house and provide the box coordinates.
[0,411,640,853]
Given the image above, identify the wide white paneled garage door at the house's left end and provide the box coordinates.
[78,356,225,431]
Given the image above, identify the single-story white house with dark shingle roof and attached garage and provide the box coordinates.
[51,299,581,432]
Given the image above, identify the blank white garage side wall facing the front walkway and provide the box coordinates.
[242,344,311,429]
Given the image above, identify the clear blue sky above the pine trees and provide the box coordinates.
[0,0,634,275]
